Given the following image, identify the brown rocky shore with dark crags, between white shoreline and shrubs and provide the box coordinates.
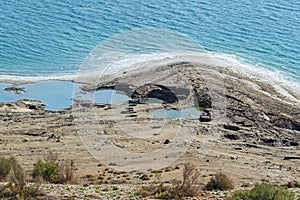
[0,63,300,199]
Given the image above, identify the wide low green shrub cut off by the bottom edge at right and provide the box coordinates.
[228,183,295,200]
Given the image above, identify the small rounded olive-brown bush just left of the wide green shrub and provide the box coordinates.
[206,173,234,191]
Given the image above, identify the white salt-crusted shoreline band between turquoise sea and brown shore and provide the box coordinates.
[0,52,300,108]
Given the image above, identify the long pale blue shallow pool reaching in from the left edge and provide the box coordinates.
[0,80,130,110]
